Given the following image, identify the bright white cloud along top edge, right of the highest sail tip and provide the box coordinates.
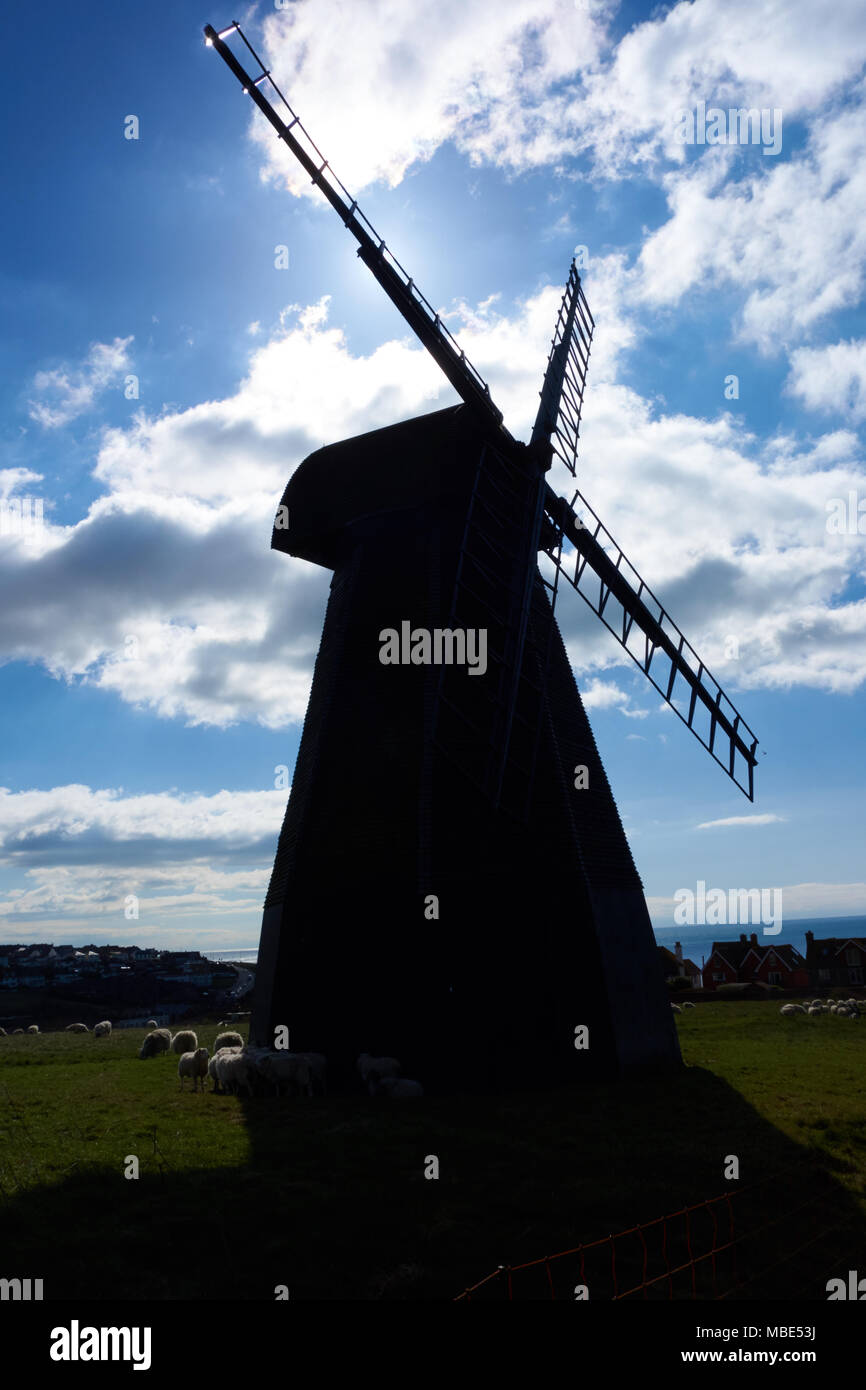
[244,0,866,193]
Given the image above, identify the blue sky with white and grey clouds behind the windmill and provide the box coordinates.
[0,0,866,949]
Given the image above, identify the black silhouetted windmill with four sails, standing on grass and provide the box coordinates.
[204,24,758,1088]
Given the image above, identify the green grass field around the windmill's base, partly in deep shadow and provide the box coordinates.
[0,1002,866,1300]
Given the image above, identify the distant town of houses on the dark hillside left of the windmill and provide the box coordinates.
[0,941,253,1027]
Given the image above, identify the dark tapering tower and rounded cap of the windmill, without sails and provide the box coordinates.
[252,406,678,1087]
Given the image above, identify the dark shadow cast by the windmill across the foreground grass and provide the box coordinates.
[1,1068,866,1301]
